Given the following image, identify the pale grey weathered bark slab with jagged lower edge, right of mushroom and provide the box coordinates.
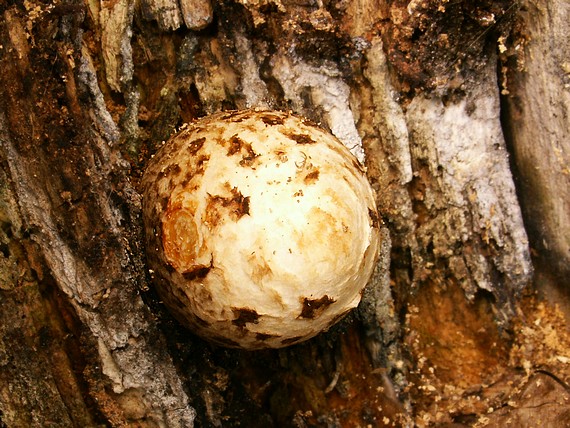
[406,58,532,320]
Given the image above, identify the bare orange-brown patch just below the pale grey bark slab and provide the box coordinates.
[408,284,506,387]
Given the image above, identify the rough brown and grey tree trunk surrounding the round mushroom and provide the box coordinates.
[0,0,570,427]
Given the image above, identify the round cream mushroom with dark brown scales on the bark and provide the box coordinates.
[142,110,379,349]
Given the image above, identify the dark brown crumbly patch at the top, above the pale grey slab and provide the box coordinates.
[383,0,518,93]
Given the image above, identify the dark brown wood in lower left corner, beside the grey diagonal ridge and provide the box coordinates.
[0,163,98,426]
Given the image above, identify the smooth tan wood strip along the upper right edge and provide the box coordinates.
[503,1,570,288]
